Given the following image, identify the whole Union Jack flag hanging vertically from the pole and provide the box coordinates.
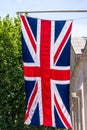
[21,16,72,129]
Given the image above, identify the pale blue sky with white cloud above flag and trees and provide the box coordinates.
[0,0,87,37]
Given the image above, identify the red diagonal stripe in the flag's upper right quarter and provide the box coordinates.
[54,23,72,63]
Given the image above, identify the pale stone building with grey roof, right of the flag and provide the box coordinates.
[70,38,87,130]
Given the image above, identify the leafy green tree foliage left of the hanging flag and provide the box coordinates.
[0,15,66,130]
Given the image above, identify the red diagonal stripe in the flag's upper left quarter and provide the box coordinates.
[21,16,36,53]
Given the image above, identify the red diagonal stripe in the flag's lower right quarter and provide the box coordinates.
[54,95,72,129]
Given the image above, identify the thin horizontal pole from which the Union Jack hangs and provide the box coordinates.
[16,10,87,14]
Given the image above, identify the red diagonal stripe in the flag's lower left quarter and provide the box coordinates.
[25,83,38,121]
